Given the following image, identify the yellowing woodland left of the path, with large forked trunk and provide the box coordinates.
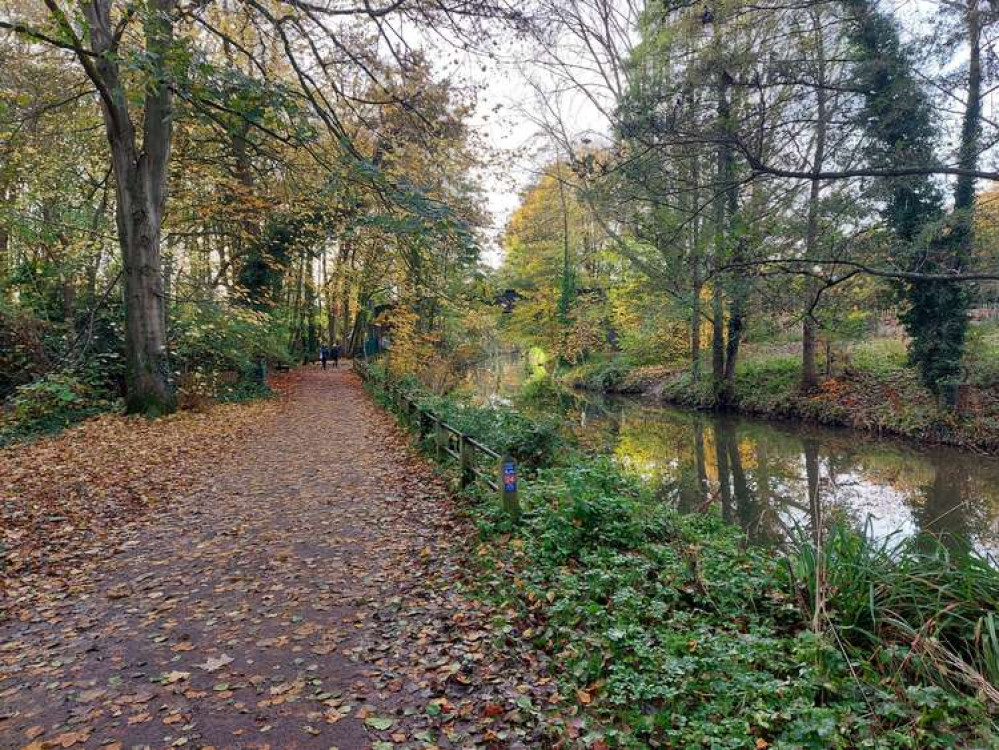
[0,0,500,434]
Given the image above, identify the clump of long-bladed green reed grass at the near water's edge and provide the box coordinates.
[787,525,999,710]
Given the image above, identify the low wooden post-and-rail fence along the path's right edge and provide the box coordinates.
[354,360,520,519]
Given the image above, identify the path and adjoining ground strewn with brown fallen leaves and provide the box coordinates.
[0,369,573,749]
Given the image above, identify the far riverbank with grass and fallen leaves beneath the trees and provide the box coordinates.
[560,341,999,455]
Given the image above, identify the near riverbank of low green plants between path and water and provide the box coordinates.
[369,362,999,748]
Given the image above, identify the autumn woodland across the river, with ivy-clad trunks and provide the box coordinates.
[500,2,999,418]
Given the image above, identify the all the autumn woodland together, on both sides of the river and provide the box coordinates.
[0,0,997,444]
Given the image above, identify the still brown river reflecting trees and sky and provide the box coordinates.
[467,357,999,559]
